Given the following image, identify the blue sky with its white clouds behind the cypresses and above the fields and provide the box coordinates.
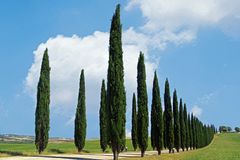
[0,0,240,138]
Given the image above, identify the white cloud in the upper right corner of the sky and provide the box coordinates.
[125,0,240,45]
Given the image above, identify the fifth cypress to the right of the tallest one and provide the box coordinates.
[173,90,180,152]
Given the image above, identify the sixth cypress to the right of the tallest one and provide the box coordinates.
[179,99,186,151]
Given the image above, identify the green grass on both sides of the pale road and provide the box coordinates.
[0,133,240,160]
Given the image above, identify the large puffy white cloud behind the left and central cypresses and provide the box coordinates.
[25,29,157,135]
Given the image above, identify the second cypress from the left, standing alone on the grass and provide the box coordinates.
[74,70,87,152]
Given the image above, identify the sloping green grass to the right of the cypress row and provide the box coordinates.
[125,133,240,160]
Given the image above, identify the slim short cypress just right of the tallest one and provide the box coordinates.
[131,93,138,151]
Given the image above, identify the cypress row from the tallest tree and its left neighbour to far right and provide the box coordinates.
[99,5,214,160]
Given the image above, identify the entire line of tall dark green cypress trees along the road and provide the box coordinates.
[35,5,215,160]
